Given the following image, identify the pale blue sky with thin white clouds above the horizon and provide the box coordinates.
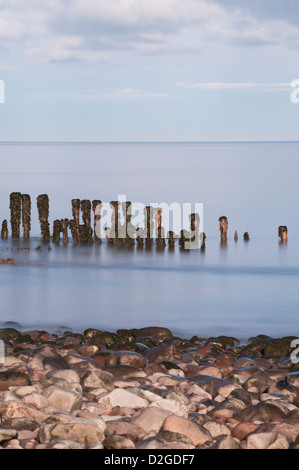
[0,0,299,142]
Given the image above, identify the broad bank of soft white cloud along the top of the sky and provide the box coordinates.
[0,0,299,63]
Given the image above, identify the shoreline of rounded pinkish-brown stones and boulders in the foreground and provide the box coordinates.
[0,327,299,449]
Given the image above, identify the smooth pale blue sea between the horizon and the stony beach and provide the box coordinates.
[0,143,299,339]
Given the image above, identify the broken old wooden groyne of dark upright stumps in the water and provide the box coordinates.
[1,192,288,251]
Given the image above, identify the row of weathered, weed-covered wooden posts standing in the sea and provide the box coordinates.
[1,192,288,250]
